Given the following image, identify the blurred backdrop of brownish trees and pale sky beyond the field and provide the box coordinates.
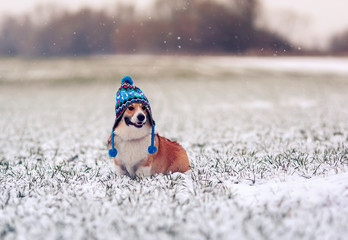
[0,0,348,57]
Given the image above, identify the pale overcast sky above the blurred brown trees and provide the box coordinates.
[0,0,348,47]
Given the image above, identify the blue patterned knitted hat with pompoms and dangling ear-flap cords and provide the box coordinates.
[109,76,157,157]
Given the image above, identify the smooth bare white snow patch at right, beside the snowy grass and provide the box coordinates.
[232,173,348,210]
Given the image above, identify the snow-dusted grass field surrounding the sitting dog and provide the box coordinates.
[0,56,348,239]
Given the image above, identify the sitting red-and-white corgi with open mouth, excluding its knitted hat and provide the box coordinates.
[108,102,190,178]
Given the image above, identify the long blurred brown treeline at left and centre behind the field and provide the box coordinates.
[0,0,292,56]
